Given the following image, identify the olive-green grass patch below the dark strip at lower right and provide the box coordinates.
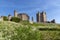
[40,30,60,40]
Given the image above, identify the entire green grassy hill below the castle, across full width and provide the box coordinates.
[0,21,60,40]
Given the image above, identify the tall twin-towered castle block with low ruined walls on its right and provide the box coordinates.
[36,11,55,23]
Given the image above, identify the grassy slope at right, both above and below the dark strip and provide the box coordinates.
[19,22,60,40]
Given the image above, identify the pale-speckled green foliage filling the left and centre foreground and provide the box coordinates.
[0,22,40,40]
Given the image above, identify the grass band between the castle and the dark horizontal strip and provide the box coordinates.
[20,22,60,29]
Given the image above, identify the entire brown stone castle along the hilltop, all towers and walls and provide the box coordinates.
[0,10,55,23]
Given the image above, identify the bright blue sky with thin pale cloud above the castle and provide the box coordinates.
[0,0,60,23]
